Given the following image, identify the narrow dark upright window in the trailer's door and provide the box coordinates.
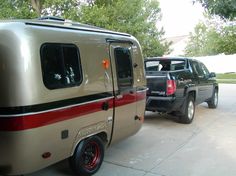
[114,48,133,88]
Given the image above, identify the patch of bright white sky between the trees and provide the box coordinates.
[157,0,204,37]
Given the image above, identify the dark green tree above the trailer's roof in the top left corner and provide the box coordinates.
[0,0,80,19]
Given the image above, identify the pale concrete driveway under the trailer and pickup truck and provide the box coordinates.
[28,84,236,176]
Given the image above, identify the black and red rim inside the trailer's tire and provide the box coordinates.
[82,142,101,170]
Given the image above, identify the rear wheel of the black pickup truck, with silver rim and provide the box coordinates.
[180,95,195,124]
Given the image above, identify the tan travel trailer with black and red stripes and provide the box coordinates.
[0,20,146,175]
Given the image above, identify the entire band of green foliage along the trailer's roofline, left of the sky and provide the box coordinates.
[0,0,170,56]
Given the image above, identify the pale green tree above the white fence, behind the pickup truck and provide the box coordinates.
[185,20,236,56]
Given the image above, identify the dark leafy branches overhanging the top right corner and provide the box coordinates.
[194,0,236,20]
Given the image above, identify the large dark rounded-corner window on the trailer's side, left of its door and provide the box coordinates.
[40,43,82,89]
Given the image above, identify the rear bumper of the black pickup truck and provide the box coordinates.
[146,96,184,112]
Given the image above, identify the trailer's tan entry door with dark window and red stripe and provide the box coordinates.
[110,42,137,143]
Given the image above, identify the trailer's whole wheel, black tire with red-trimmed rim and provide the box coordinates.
[69,136,104,176]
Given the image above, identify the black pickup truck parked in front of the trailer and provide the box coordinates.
[145,57,219,123]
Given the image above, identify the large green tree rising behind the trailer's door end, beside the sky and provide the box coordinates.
[79,0,170,56]
